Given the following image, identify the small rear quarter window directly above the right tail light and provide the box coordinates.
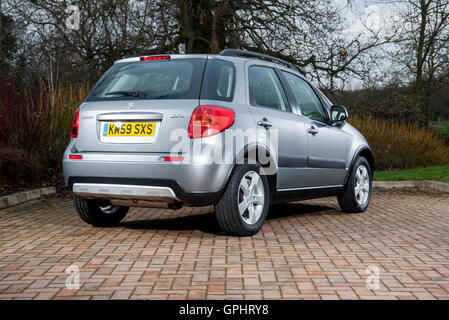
[201,59,235,102]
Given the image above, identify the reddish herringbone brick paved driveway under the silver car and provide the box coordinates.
[0,192,449,299]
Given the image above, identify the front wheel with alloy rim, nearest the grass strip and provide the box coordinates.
[337,156,373,213]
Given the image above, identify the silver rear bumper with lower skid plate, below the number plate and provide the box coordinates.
[63,153,233,206]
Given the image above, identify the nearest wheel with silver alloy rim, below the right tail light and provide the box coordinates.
[215,164,270,237]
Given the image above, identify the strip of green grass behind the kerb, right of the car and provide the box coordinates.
[374,167,449,183]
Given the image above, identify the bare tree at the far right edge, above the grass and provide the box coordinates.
[388,0,449,126]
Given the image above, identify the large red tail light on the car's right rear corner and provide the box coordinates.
[189,106,235,138]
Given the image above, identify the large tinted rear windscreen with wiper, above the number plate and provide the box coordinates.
[86,59,205,101]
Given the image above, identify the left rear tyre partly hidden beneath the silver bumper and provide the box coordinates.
[74,197,129,227]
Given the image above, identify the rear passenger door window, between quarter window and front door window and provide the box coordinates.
[248,66,290,111]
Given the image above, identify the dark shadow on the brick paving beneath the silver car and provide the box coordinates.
[120,203,339,234]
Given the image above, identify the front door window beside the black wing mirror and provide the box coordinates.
[282,71,326,122]
